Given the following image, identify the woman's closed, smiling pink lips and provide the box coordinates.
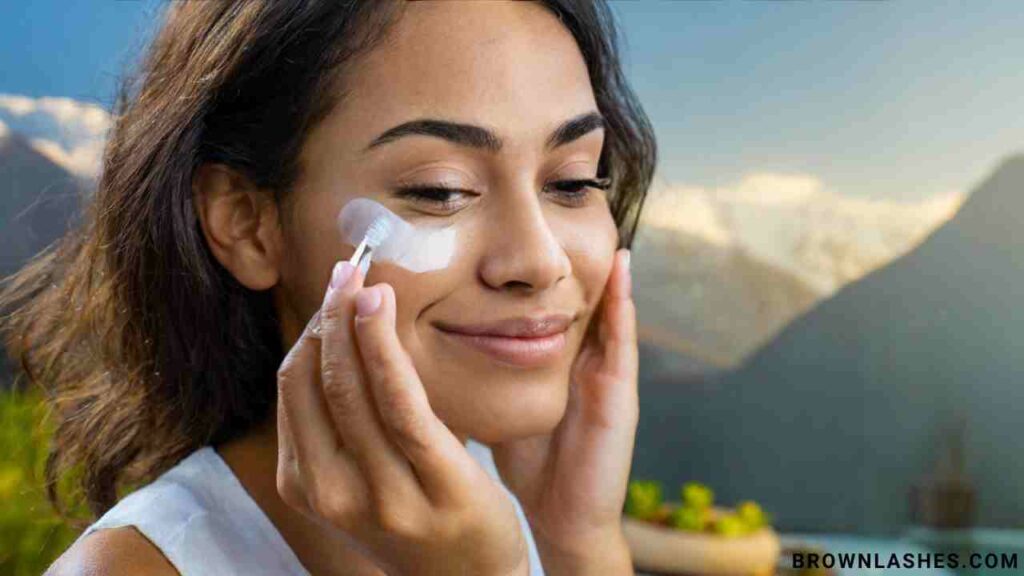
[435,315,575,368]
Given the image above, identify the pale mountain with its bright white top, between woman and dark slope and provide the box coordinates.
[634,173,963,367]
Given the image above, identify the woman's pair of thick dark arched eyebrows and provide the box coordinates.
[362,111,605,154]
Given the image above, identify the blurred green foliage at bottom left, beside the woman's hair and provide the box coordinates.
[0,388,86,576]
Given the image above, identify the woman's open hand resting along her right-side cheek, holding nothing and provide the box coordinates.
[490,245,640,574]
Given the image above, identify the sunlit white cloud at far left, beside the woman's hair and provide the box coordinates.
[0,93,111,178]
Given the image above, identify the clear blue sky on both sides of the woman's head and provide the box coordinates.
[0,0,1024,200]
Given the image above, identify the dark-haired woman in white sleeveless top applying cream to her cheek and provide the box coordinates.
[3,0,655,575]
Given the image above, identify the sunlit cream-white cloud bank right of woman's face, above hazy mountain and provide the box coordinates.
[641,172,964,294]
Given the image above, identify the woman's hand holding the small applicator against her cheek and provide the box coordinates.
[278,262,529,576]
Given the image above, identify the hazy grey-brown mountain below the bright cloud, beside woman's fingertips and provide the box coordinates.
[633,227,819,366]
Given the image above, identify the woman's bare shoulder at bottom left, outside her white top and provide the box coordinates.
[44,526,180,576]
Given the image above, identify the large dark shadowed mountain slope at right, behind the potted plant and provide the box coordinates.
[634,155,1024,533]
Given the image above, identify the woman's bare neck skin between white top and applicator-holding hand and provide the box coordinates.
[216,407,467,576]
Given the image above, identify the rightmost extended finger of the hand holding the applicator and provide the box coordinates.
[355,283,485,501]
